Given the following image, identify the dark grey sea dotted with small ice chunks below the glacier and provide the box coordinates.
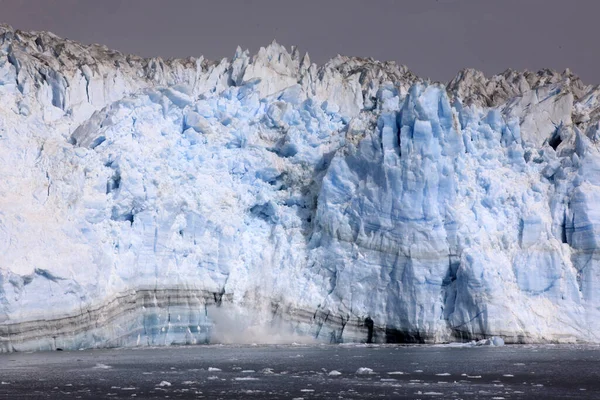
[0,345,600,400]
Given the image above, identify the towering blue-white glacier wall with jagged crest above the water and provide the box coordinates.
[0,25,600,351]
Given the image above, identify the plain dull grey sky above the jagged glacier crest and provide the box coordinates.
[0,0,600,83]
